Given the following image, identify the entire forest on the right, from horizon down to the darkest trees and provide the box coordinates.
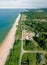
[22,9,47,50]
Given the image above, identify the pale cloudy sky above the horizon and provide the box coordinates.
[0,0,47,8]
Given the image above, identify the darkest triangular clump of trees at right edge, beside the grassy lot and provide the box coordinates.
[34,32,47,50]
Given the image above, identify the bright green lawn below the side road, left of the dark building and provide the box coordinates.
[22,53,36,65]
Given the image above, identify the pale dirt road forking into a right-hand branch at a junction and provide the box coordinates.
[19,30,47,65]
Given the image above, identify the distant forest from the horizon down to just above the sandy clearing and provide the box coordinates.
[23,10,47,32]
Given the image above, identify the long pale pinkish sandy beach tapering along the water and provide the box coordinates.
[0,14,21,65]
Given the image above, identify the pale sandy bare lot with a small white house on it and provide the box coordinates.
[22,30,35,40]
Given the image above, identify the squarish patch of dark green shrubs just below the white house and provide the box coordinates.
[23,40,35,50]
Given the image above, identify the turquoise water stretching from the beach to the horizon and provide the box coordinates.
[0,9,21,42]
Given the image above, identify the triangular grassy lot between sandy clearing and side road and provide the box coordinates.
[23,40,43,51]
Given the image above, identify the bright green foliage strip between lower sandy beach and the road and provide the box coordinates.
[5,40,21,65]
